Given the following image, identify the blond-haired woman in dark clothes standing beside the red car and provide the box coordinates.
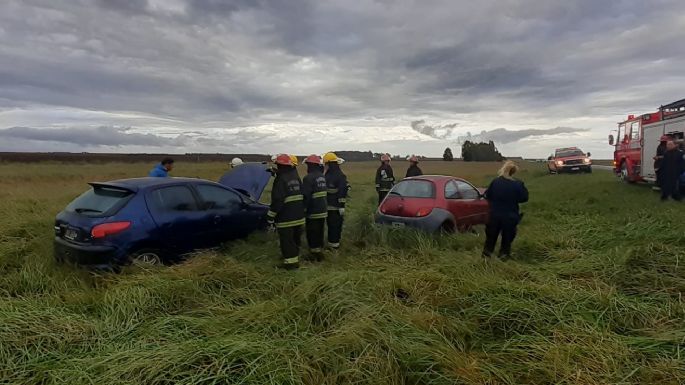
[483,161,528,259]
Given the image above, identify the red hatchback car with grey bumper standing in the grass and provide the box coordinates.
[376,175,490,232]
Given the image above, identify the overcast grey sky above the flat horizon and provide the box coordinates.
[0,0,685,157]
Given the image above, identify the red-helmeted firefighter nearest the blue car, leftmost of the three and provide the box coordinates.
[267,154,305,270]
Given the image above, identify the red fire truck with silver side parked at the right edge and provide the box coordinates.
[609,99,685,183]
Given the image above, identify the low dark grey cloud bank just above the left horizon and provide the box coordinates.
[0,127,187,147]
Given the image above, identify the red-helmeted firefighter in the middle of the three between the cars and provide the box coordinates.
[302,155,328,262]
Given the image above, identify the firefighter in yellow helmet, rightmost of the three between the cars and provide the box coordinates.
[323,152,350,250]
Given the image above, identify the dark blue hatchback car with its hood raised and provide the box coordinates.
[54,164,271,269]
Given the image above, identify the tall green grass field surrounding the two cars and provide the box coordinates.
[0,162,685,385]
